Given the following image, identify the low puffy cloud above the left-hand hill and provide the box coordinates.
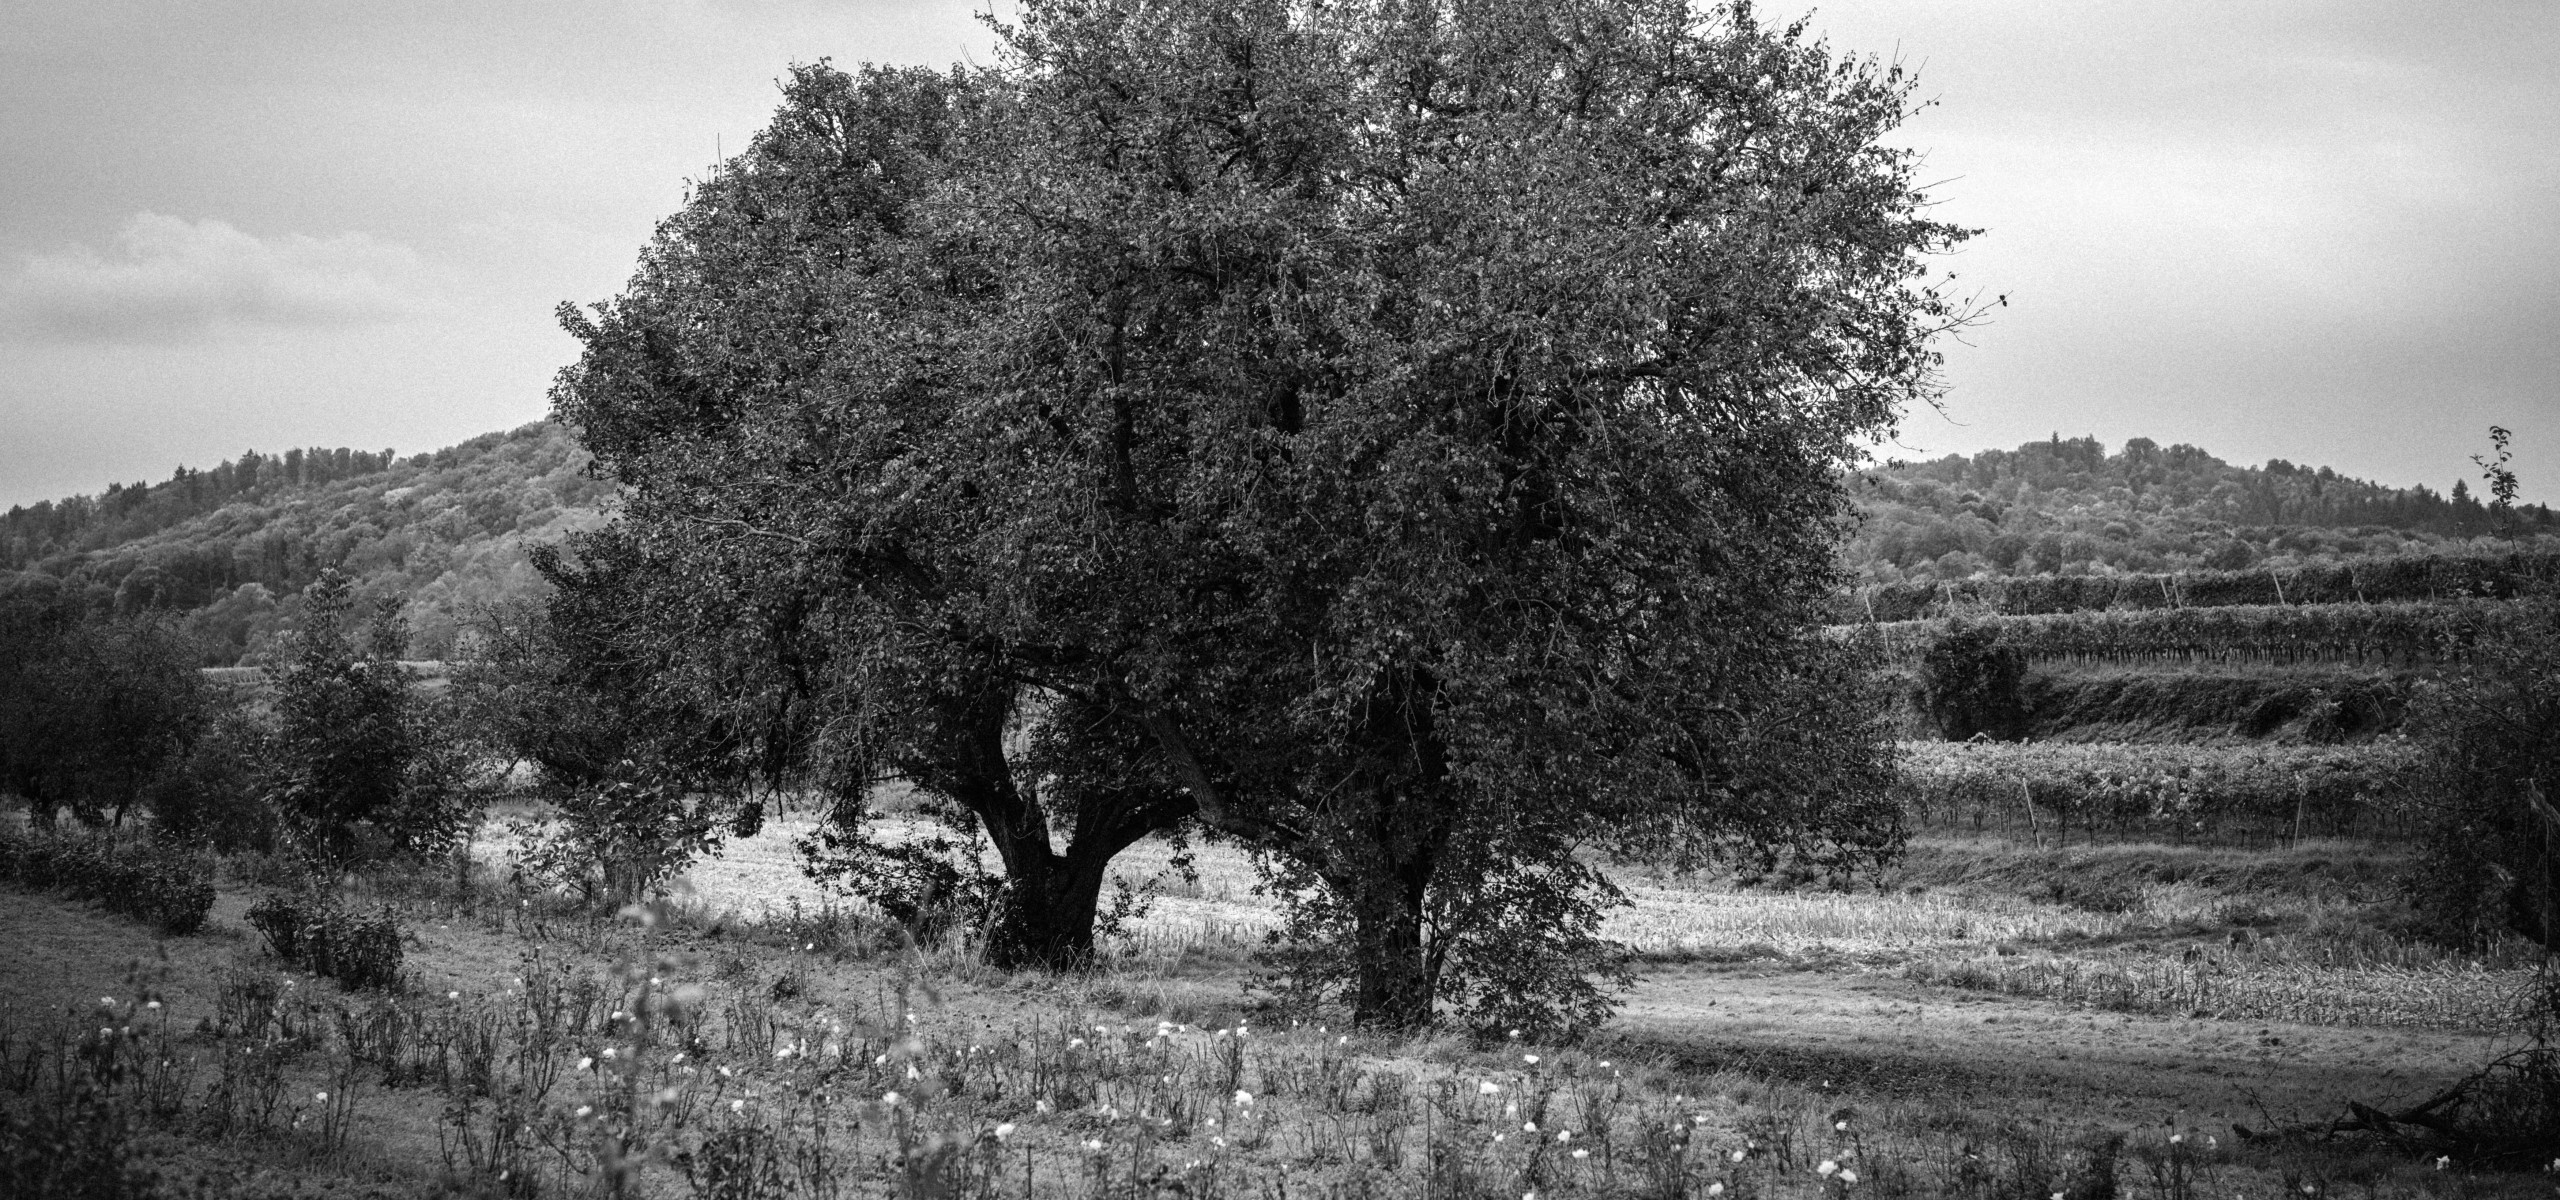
[0,212,425,343]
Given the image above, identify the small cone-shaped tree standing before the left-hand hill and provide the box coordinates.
[266,571,484,875]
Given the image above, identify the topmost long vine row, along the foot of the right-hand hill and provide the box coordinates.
[1833,553,2560,622]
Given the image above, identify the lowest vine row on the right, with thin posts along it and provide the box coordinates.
[1900,742,2417,837]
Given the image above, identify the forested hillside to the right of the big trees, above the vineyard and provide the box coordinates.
[1846,438,2560,583]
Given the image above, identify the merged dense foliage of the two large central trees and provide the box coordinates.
[558,0,1964,1029]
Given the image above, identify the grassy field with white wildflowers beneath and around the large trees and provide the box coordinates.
[0,821,2547,1197]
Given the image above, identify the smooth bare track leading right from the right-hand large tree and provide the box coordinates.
[1613,967,2499,1128]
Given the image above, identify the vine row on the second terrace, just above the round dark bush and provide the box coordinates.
[1833,601,2506,665]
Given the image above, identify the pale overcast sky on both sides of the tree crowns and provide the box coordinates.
[0,0,2560,504]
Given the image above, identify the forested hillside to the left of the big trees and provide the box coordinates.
[0,422,609,665]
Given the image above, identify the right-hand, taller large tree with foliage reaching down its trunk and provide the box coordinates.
[937,0,1961,1026]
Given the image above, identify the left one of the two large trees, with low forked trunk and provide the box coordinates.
[556,64,1190,967]
